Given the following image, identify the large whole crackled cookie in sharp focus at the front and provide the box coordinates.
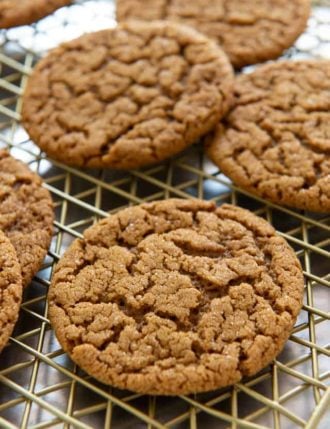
[48,200,303,395]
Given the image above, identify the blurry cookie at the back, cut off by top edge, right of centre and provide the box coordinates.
[117,0,310,68]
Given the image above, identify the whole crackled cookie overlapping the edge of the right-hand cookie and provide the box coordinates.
[23,22,233,169]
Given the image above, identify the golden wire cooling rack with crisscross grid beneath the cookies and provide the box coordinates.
[0,0,330,429]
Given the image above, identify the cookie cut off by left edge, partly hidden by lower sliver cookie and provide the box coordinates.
[0,150,54,286]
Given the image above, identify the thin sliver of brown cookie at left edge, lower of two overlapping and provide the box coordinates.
[0,231,23,352]
